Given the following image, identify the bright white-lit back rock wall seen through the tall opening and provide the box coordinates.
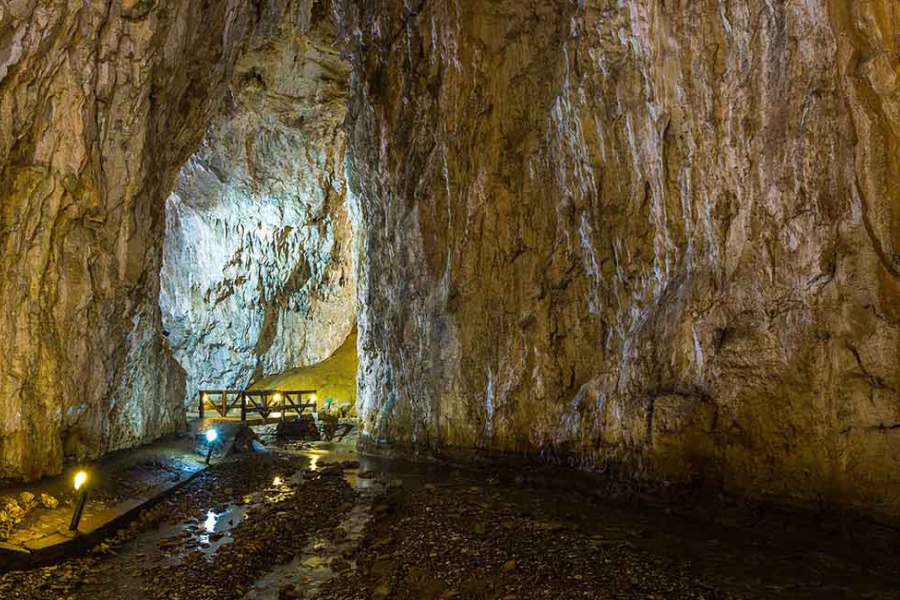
[160,6,356,404]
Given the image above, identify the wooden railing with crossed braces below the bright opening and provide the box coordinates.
[199,390,316,421]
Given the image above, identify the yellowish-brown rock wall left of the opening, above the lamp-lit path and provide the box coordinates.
[0,0,326,479]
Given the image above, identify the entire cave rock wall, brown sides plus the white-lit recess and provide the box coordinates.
[0,0,900,514]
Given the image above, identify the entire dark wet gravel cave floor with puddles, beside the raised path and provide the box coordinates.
[0,438,900,600]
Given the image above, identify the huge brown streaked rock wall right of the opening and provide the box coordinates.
[345,0,900,513]
